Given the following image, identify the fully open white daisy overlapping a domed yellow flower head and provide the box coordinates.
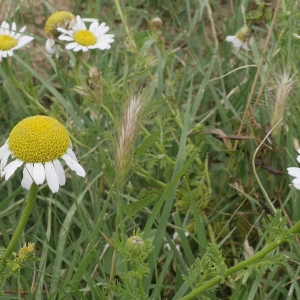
[57,16,115,52]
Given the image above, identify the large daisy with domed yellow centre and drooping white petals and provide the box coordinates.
[0,116,86,193]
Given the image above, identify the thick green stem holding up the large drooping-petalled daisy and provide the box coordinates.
[2,182,39,265]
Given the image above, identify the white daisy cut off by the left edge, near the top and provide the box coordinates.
[0,21,34,62]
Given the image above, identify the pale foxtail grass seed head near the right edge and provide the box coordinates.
[270,72,294,138]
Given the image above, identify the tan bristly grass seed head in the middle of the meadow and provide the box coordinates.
[116,94,143,185]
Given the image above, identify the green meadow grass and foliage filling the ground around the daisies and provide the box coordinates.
[0,0,300,300]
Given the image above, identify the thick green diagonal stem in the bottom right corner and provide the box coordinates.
[181,221,300,300]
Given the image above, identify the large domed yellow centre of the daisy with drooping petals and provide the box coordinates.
[8,116,70,163]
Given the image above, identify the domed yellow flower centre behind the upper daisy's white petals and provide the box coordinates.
[45,11,75,38]
